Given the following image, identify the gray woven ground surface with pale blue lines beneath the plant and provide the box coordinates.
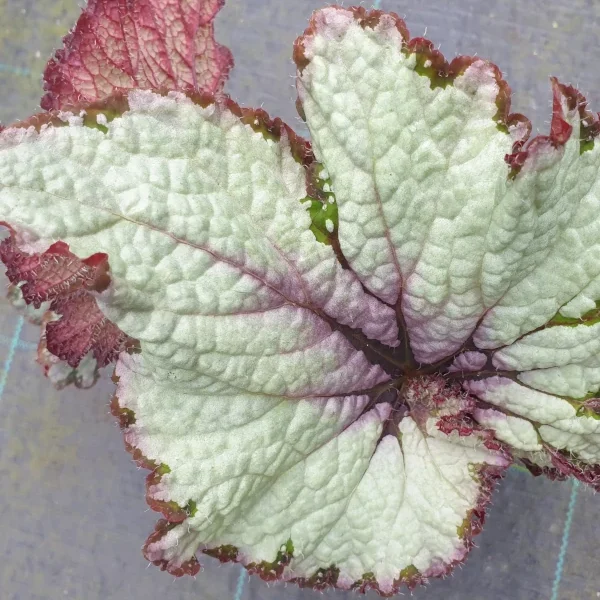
[0,0,600,600]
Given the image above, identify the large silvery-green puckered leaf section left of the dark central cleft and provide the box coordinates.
[0,92,508,591]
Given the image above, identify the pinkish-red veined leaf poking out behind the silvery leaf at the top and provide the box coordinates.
[41,0,233,110]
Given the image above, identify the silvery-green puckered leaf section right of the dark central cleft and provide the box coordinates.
[296,8,600,485]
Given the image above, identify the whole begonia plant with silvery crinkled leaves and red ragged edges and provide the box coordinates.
[0,0,600,596]
